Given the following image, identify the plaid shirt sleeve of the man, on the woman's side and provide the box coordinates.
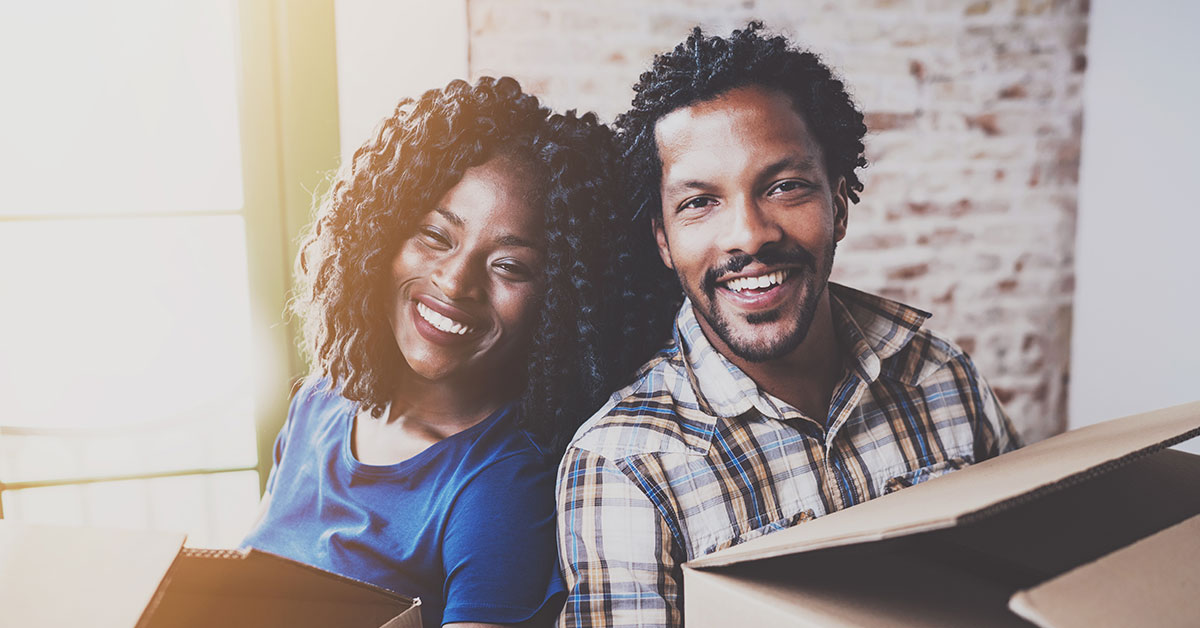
[558,449,683,628]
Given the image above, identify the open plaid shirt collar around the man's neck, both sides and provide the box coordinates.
[674,282,930,419]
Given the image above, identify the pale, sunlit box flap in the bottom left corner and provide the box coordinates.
[0,521,185,628]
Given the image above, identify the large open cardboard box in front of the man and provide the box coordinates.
[684,402,1200,628]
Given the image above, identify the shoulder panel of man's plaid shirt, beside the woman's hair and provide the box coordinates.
[570,346,698,460]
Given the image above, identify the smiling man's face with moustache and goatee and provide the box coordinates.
[654,86,847,361]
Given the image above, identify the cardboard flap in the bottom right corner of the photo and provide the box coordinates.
[1008,515,1200,628]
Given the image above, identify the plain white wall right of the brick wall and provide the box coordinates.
[1068,0,1200,453]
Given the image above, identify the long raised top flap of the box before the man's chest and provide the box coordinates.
[688,402,1200,569]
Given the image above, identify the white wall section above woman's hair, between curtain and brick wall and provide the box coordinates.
[334,0,469,163]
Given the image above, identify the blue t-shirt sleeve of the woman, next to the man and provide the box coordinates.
[442,455,565,623]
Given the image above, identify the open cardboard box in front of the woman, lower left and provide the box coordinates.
[0,521,421,628]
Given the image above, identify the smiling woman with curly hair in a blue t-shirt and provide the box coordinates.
[245,78,648,626]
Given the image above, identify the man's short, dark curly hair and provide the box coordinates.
[616,22,866,231]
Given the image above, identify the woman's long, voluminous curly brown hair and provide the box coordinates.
[294,77,653,449]
